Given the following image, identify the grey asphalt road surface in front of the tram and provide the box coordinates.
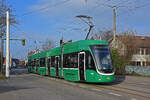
[0,69,149,100]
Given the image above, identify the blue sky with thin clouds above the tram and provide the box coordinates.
[3,0,150,58]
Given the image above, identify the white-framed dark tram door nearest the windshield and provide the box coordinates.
[78,52,85,81]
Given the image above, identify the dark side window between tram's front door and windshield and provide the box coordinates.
[85,52,95,69]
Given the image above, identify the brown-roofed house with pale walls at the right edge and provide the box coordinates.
[131,36,150,66]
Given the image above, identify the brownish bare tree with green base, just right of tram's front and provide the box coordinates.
[111,30,136,74]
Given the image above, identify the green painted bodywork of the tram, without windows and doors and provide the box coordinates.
[28,40,114,82]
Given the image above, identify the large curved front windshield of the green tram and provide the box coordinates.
[91,45,113,73]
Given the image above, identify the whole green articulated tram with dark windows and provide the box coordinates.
[28,40,114,83]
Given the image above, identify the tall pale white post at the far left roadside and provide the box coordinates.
[6,10,10,78]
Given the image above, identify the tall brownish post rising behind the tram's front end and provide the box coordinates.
[113,7,116,47]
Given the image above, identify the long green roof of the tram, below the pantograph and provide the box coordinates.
[29,40,108,59]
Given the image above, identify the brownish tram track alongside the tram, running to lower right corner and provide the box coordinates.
[30,74,150,100]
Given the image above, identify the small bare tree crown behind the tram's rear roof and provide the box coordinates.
[42,39,55,50]
